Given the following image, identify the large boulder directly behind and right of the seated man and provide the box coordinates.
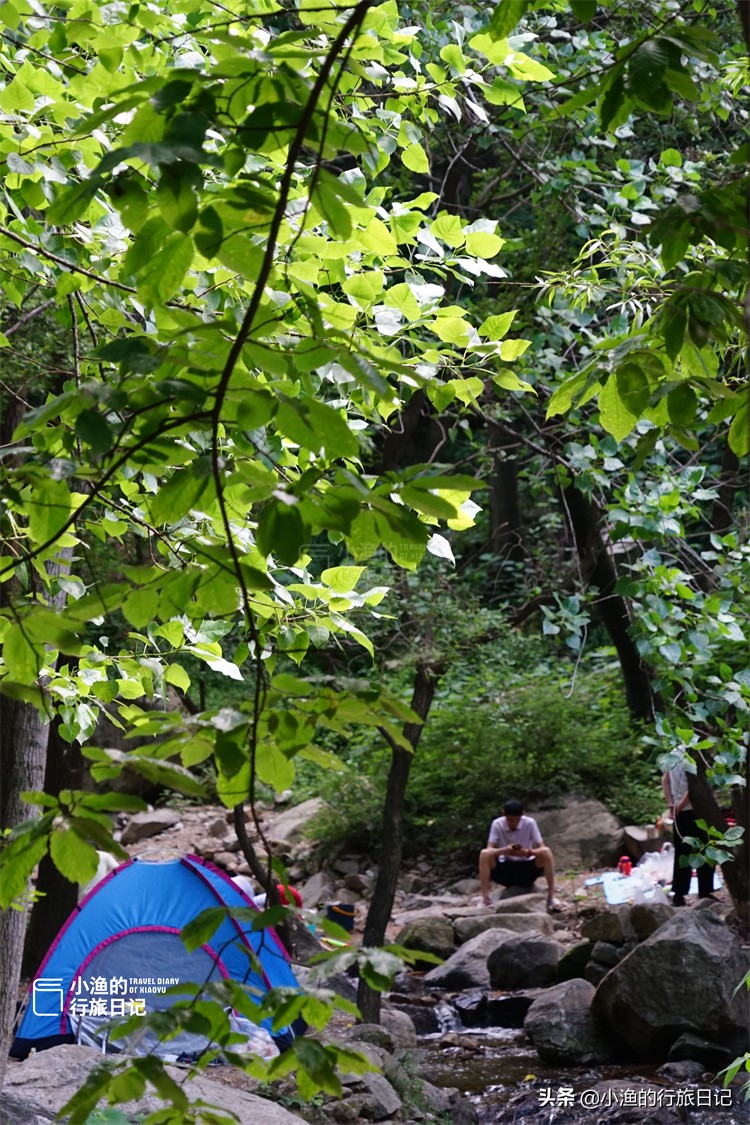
[531,797,623,871]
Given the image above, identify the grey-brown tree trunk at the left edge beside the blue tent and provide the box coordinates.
[0,696,49,1090]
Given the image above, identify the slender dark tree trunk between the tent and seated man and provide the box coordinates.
[356,660,444,1024]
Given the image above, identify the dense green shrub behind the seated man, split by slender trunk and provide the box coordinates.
[305,668,662,858]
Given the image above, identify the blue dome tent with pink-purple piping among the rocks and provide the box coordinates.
[11,855,299,1059]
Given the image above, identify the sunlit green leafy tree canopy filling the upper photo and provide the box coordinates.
[0,0,750,1107]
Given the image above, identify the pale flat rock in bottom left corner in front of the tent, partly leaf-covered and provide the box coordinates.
[2,1045,305,1125]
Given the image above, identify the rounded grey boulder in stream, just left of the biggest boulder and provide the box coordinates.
[524,980,616,1067]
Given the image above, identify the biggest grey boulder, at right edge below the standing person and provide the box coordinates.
[593,909,750,1059]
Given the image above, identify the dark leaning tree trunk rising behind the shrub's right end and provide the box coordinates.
[562,485,654,719]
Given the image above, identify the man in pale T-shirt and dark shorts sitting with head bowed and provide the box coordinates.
[479,801,561,912]
